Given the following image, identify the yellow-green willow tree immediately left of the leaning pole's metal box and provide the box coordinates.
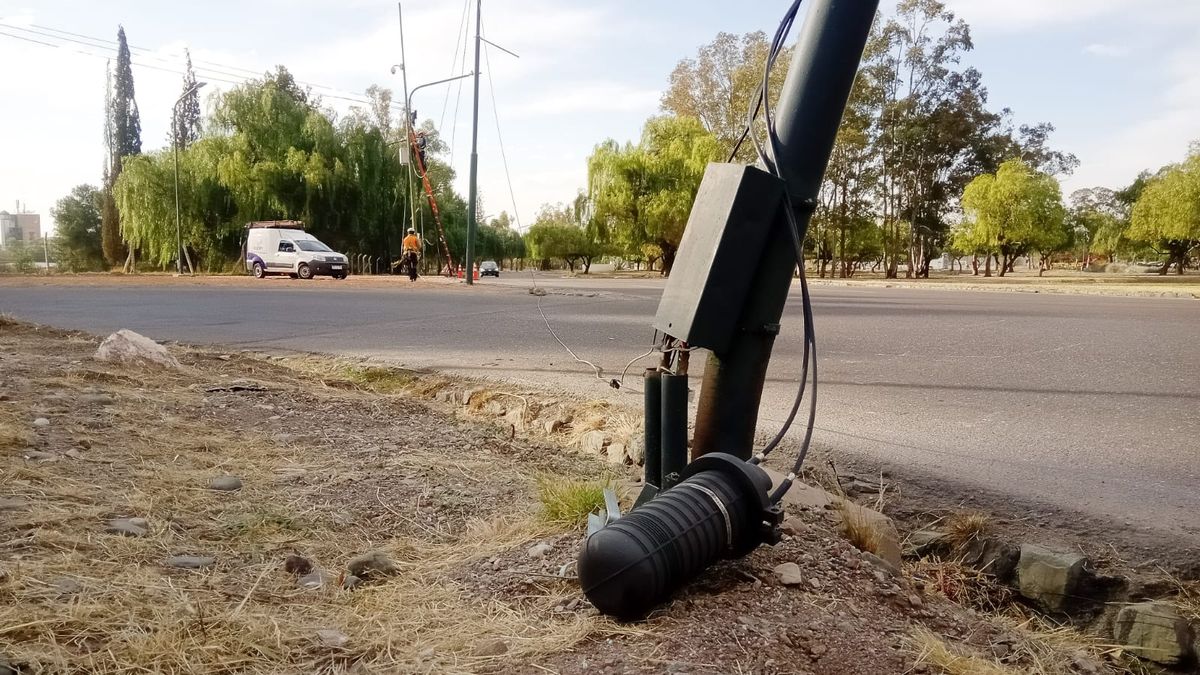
[588,117,721,274]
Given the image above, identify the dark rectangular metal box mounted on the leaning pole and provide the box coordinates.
[654,163,785,353]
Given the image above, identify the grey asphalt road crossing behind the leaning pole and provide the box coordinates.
[0,270,1200,540]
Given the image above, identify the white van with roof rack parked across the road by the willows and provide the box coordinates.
[245,220,349,279]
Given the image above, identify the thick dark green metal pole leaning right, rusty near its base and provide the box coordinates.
[692,0,878,459]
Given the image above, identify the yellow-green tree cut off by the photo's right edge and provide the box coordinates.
[1128,153,1200,274]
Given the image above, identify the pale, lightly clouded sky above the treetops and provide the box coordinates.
[0,0,1200,233]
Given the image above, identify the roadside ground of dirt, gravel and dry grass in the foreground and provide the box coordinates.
[0,317,1152,675]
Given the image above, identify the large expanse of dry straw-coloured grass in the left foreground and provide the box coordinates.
[0,324,636,674]
